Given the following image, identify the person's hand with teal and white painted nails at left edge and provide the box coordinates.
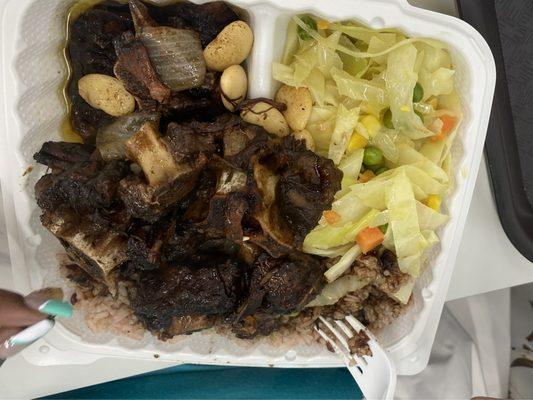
[0,289,72,360]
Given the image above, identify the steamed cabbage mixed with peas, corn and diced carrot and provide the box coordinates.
[273,15,461,305]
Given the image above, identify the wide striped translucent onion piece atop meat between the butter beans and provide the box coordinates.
[138,26,206,92]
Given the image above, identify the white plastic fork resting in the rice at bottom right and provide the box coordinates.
[315,315,396,400]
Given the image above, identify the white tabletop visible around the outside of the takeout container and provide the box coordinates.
[0,0,533,399]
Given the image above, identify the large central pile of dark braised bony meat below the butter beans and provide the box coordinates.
[36,114,341,337]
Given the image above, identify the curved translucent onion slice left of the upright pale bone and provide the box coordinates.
[96,111,159,161]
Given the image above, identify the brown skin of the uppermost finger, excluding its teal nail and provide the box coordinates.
[0,290,46,328]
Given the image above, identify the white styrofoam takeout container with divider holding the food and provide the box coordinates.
[0,0,496,375]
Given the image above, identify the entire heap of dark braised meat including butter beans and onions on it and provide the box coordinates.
[34,0,360,340]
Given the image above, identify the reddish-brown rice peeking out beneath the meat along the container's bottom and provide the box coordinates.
[57,265,408,347]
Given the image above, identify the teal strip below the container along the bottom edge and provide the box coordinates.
[45,365,363,400]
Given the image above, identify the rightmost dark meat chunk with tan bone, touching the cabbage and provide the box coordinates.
[244,137,342,253]
